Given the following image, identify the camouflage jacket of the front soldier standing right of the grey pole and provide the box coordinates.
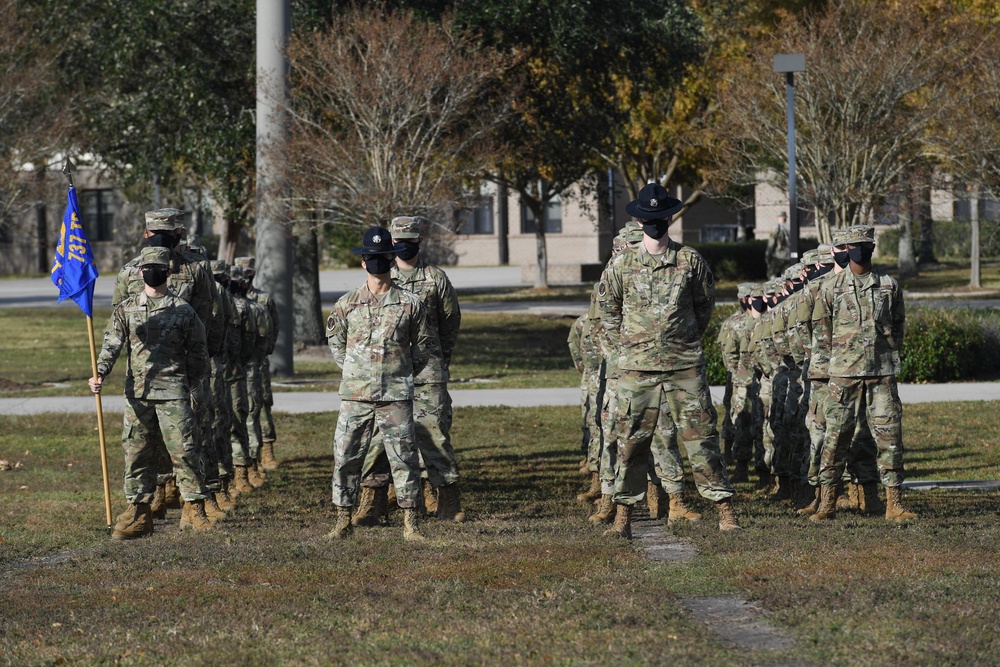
[326,283,443,401]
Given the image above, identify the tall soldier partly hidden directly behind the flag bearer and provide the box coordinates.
[111,208,224,519]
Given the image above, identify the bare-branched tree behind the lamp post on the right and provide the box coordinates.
[715,0,968,241]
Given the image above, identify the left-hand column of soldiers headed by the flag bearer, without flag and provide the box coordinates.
[89,209,279,540]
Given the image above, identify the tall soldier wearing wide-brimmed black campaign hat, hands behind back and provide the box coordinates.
[598,183,740,539]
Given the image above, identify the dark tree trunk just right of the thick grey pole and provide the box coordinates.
[292,222,326,346]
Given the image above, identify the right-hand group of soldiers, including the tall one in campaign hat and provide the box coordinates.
[568,184,916,538]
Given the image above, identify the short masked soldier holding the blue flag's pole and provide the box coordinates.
[89,248,211,540]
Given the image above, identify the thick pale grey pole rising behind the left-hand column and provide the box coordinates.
[254,0,294,375]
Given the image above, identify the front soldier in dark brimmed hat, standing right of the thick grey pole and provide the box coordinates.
[327,227,445,541]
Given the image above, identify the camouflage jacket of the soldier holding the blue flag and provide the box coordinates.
[97,291,210,401]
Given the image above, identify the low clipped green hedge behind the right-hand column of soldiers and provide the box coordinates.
[702,306,1000,385]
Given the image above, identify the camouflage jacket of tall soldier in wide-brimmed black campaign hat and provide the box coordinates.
[598,241,715,371]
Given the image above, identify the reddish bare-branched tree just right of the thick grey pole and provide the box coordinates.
[285,4,507,231]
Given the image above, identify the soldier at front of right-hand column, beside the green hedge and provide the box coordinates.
[809,225,917,522]
